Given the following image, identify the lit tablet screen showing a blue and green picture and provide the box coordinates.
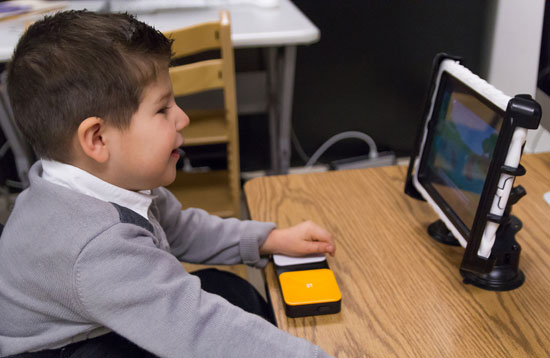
[421,73,503,236]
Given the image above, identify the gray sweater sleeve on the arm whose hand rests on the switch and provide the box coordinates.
[155,188,275,267]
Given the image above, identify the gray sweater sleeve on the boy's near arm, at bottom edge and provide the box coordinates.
[73,224,327,358]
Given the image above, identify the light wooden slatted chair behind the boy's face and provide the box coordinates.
[165,11,240,217]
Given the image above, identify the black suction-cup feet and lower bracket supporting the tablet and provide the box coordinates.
[428,186,526,291]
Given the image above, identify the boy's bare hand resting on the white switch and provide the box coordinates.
[260,221,334,256]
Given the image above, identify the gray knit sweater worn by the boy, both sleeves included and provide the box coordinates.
[0,163,326,358]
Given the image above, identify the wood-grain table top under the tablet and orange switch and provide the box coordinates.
[245,153,550,358]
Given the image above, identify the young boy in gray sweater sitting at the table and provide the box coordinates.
[0,11,334,358]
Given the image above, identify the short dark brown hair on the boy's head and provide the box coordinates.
[8,11,172,162]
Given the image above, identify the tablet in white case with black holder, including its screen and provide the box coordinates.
[408,56,540,272]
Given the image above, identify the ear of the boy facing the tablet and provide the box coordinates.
[77,117,109,163]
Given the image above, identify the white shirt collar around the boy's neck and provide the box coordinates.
[41,159,155,220]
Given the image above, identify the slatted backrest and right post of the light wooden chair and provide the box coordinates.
[164,10,240,215]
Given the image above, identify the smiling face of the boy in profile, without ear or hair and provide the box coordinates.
[108,71,189,190]
